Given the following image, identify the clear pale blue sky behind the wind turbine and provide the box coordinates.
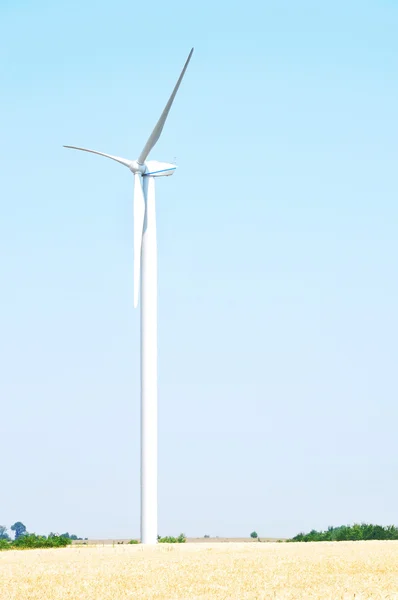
[0,0,398,537]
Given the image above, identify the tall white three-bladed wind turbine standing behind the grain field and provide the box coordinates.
[64,48,193,544]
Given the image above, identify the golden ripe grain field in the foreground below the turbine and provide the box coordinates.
[0,541,398,600]
